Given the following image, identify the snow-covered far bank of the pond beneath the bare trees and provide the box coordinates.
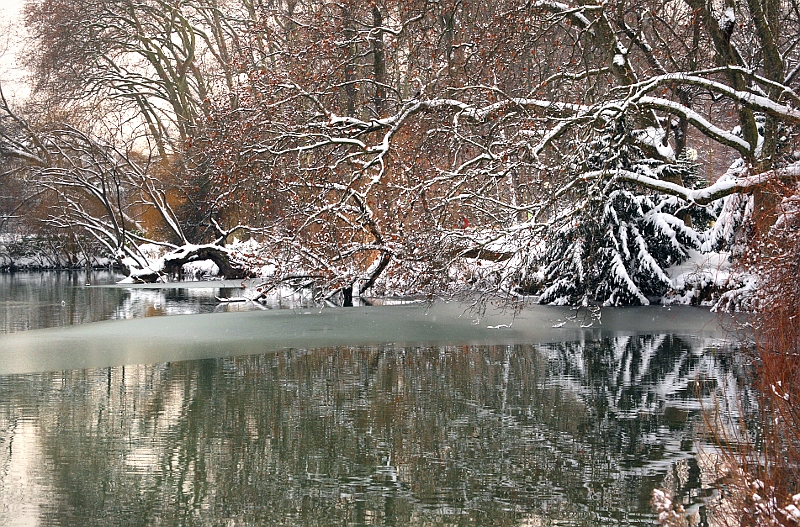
[0,235,757,311]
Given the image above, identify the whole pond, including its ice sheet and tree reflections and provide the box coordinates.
[0,275,744,527]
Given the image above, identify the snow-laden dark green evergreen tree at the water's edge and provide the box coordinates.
[540,125,704,306]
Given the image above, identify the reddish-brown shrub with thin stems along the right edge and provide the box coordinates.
[716,184,800,526]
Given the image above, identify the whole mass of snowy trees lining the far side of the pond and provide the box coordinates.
[0,0,800,305]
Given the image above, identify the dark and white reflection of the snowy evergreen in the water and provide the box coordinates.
[550,335,755,521]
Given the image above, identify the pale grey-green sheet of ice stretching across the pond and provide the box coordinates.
[0,302,726,375]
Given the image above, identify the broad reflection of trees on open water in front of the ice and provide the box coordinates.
[0,337,752,525]
